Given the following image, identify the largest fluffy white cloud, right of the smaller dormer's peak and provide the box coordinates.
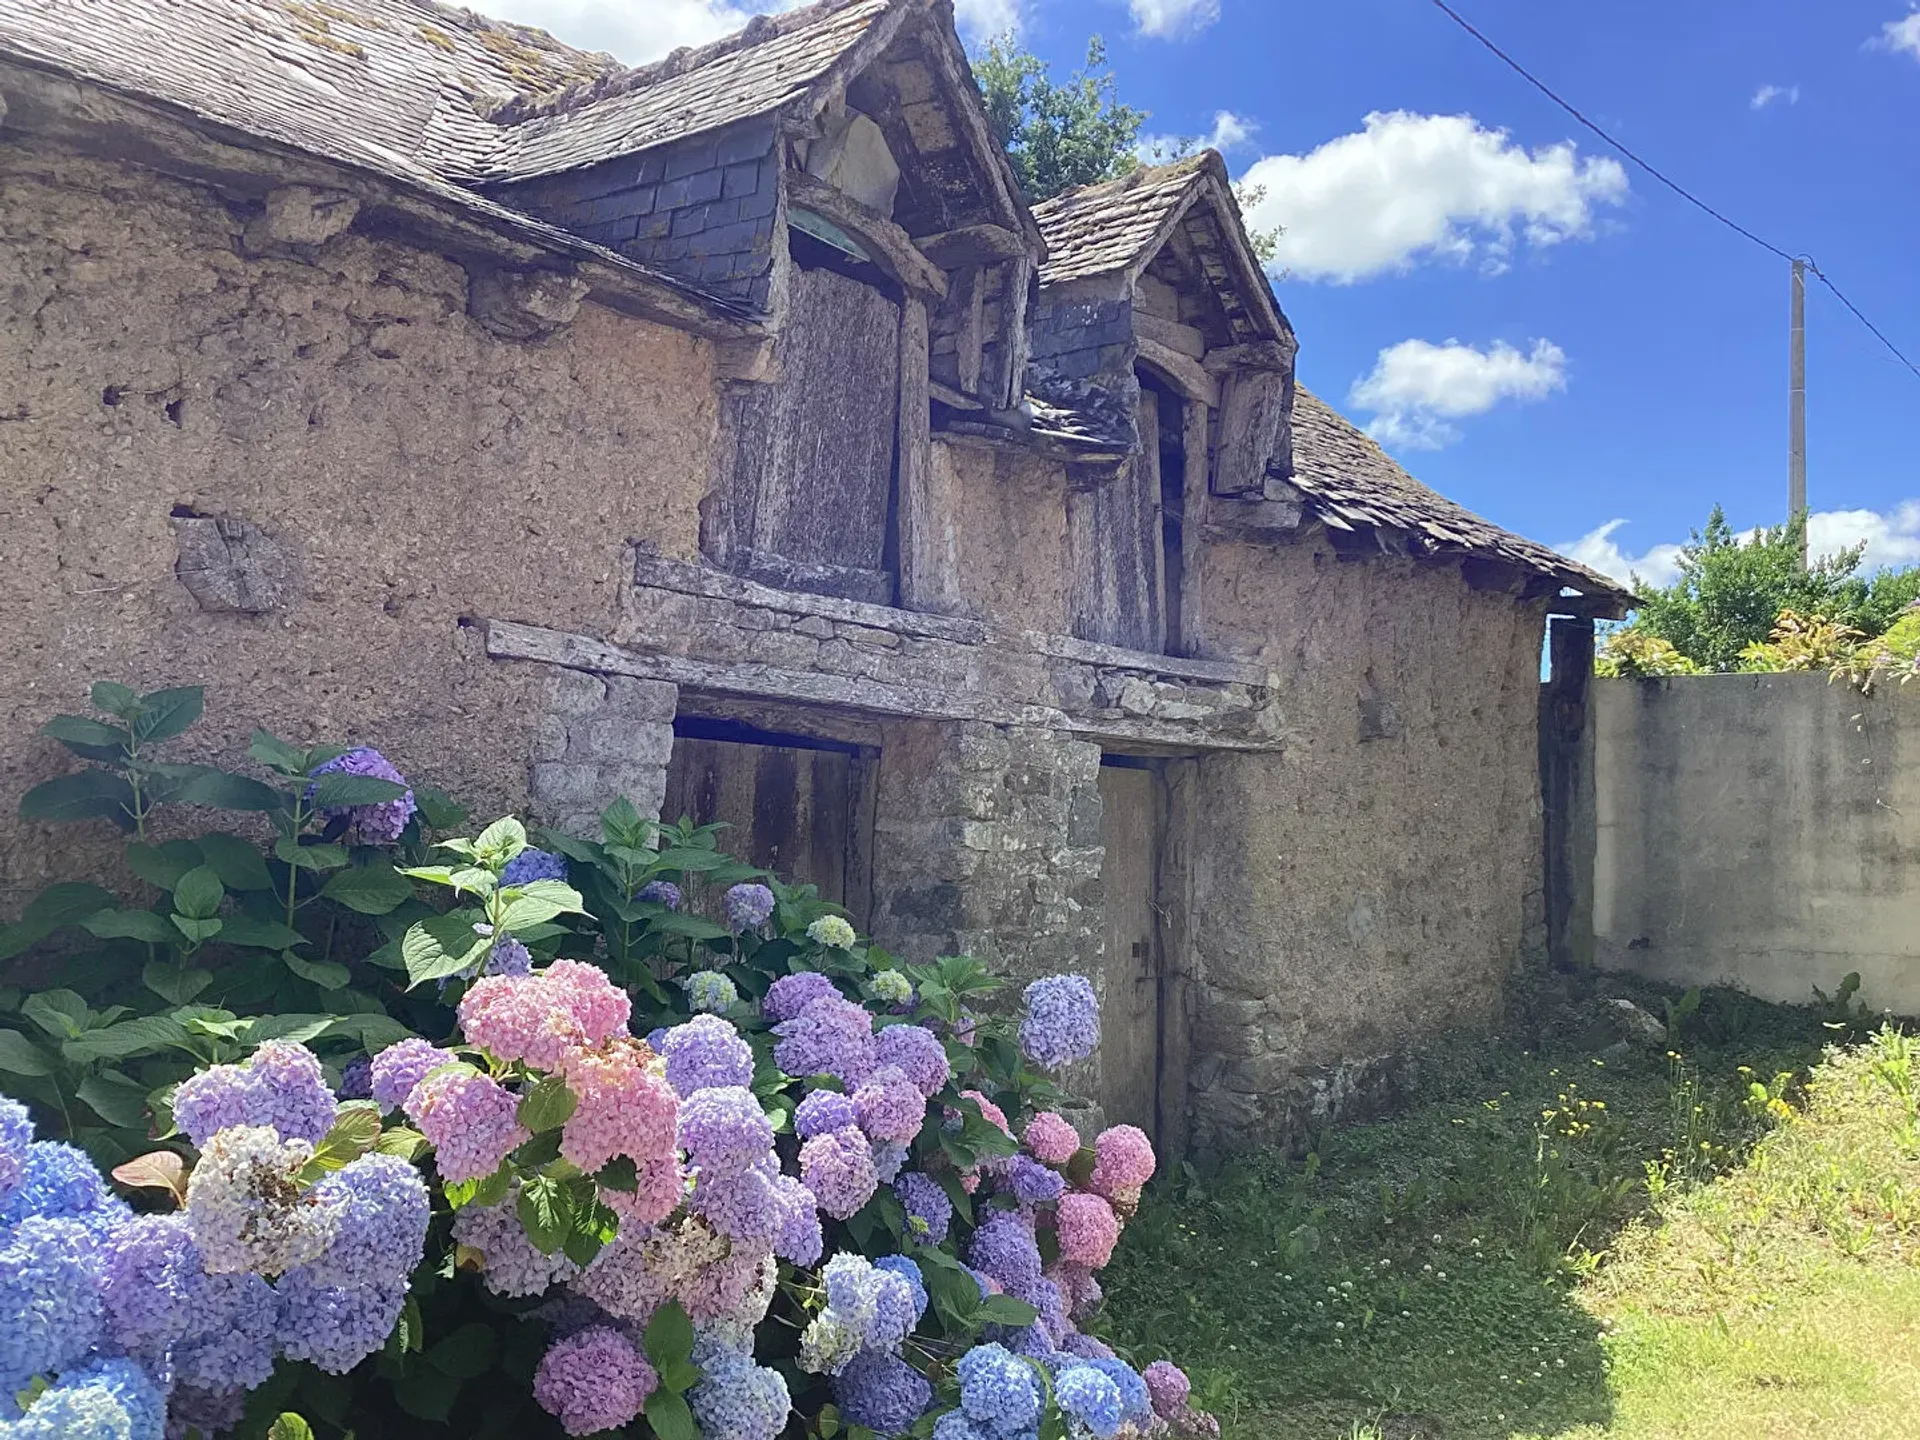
[1242,109,1628,284]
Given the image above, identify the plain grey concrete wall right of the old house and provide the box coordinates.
[1592,674,1920,1016]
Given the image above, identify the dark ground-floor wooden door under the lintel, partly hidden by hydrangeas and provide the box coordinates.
[660,735,874,927]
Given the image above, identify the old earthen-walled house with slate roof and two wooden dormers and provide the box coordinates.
[0,0,1624,1148]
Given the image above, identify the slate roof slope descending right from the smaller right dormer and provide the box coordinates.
[1286,386,1632,601]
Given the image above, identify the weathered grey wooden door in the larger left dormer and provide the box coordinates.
[728,269,900,605]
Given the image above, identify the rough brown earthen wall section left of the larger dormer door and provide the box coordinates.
[0,132,714,914]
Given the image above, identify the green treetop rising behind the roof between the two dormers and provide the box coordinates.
[973,35,1146,204]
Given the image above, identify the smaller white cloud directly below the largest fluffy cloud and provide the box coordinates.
[1348,340,1567,449]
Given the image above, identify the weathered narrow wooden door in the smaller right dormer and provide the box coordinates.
[1068,390,1179,655]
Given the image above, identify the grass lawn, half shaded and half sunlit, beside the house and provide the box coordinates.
[1106,975,1920,1440]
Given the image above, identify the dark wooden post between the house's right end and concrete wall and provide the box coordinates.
[1540,614,1597,970]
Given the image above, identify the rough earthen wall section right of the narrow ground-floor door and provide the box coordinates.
[1190,534,1546,1150]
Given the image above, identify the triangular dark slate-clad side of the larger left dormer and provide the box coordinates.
[499,119,780,311]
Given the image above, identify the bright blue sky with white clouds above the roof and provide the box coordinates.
[482,0,1920,578]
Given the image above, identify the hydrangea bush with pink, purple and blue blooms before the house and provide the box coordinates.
[0,698,1217,1440]
